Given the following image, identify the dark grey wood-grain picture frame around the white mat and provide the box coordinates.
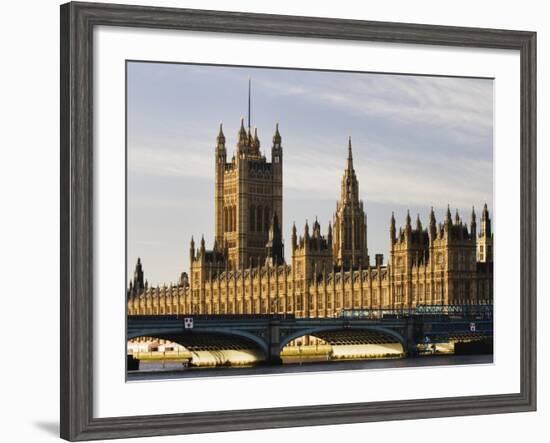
[60,3,536,441]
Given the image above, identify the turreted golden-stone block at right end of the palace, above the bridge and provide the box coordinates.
[390,207,484,309]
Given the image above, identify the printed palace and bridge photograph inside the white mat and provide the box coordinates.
[125,60,500,382]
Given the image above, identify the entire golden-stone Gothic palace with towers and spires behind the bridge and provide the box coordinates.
[127,120,493,317]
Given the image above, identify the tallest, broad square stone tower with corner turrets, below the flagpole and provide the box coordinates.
[214,119,283,269]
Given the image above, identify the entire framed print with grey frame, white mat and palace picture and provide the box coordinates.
[61,3,536,440]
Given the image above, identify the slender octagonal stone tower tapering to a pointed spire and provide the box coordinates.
[332,137,369,268]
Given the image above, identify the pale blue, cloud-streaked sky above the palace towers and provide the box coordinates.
[127,62,493,285]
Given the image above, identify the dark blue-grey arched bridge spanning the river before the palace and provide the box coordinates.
[127,305,493,363]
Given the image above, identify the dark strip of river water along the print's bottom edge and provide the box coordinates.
[127,354,493,381]
